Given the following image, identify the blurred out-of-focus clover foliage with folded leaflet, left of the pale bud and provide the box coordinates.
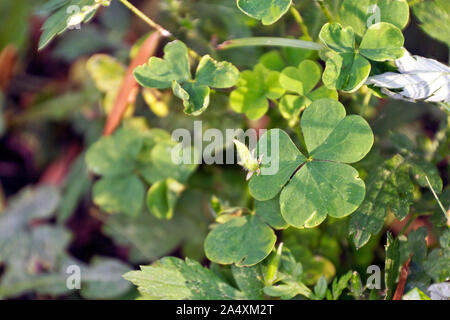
[86,128,196,219]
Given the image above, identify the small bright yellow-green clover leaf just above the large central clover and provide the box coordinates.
[279,60,338,124]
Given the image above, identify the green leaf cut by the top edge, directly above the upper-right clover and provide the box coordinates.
[339,0,409,36]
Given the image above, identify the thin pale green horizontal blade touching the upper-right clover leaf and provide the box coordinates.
[217,37,323,50]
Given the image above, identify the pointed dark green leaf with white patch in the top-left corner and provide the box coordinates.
[37,0,111,50]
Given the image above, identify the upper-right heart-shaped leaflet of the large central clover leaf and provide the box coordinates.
[301,99,374,163]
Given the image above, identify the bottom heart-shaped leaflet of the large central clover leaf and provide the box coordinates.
[280,161,365,228]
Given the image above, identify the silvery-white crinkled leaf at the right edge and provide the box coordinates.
[367,52,450,102]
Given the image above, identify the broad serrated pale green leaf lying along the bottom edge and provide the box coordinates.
[123,257,245,300]
